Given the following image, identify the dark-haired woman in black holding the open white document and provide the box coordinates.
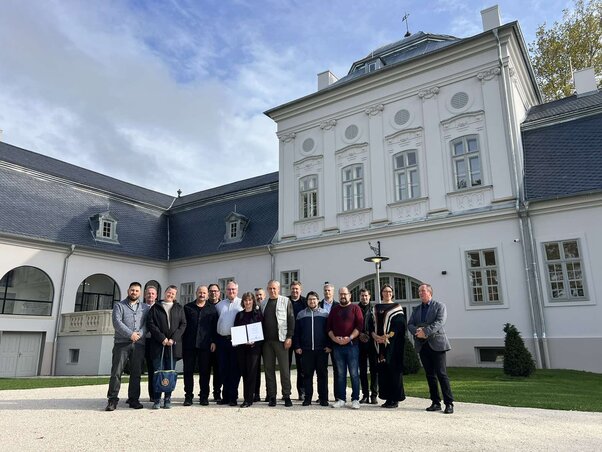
[232,292,263,408]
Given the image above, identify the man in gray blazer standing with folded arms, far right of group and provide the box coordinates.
[408,284,454,414]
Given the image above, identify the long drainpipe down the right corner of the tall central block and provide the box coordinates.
[492,28,546,368]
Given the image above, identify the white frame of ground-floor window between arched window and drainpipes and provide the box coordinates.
[463,247,504,307]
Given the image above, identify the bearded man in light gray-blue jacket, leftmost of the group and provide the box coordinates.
[105,282,149,411]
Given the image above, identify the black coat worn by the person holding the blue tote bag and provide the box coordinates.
[147,301,186,359]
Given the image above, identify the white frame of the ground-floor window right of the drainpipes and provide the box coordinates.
[541,238,589,304]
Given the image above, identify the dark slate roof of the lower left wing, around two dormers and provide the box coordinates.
[0,142,278,260]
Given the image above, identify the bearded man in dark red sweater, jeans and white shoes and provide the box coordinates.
[326,287,364,410]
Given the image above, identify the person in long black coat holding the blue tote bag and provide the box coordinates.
[147,286,186,410]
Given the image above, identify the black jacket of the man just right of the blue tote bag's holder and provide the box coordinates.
[182,301,217,350]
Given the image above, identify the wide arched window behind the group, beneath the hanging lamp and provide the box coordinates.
[348,273,422,312]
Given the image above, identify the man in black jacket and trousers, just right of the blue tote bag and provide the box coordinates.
[183,286,217,406]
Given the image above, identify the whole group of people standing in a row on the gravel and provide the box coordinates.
[106,280,453,414]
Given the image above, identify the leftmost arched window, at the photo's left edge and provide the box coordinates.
[0,265,54,315]
